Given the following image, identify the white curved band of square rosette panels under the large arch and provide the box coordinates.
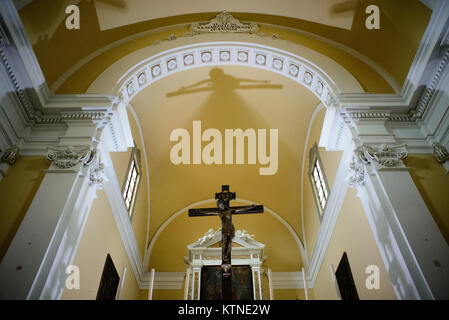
[113,41,340,106]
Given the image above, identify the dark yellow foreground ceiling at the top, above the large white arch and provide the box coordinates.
[19,0,431,93]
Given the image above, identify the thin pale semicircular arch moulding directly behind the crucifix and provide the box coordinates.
[146,198,308,269]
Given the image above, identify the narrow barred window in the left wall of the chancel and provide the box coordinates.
[122,147,142,219]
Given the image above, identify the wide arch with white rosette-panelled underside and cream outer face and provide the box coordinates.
[87,34,364,99]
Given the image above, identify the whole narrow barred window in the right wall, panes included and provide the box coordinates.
[309,143,329,220]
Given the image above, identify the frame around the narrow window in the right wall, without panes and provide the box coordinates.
[308,142,331,222]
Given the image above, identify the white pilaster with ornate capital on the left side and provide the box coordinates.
[0,121,105,299]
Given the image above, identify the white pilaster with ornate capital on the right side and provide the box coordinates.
[349,145,449,299]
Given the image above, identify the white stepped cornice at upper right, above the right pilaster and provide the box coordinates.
[337,1,449,123]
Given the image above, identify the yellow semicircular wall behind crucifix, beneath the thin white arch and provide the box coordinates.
[149,201,303,272]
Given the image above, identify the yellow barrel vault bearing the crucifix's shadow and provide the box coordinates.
[131,66,319,255]
